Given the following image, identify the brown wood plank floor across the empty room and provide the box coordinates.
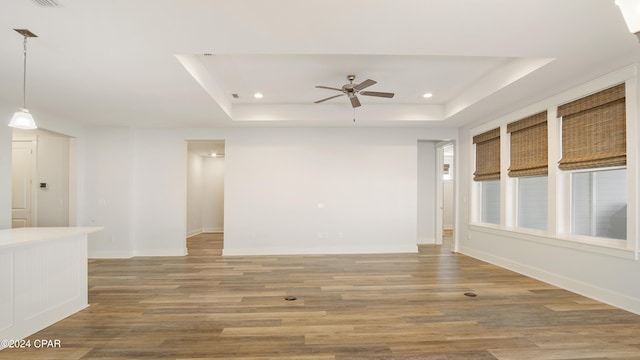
[0,234,640,360]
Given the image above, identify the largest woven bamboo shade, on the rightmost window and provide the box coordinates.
[558,84,627,170]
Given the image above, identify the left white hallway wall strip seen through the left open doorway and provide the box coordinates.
[187,152,204,237]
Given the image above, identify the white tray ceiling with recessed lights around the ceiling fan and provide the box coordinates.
[0,0,640,127]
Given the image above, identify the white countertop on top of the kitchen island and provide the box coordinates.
[0,227,103,250]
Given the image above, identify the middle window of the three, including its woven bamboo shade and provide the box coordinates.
[507,111,549,230]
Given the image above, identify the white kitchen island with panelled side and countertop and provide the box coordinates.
[0,227,102,342]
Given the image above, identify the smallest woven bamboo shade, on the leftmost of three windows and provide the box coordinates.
[473,128,500,181]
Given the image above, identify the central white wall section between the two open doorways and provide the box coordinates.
[224,129,424,255]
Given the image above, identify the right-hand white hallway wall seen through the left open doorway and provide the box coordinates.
[202,157,224,232]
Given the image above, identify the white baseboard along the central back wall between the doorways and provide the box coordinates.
[222,245,418,256]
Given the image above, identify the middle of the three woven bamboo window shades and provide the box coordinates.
[507,111,549,177]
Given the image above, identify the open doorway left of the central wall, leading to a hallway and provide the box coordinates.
[186,140,225,250]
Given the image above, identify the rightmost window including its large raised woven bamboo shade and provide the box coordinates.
[558,84,627,239]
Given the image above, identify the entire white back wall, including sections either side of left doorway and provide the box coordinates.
[31,127,457,257]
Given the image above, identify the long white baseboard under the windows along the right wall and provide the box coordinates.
[459,246,640,315]
